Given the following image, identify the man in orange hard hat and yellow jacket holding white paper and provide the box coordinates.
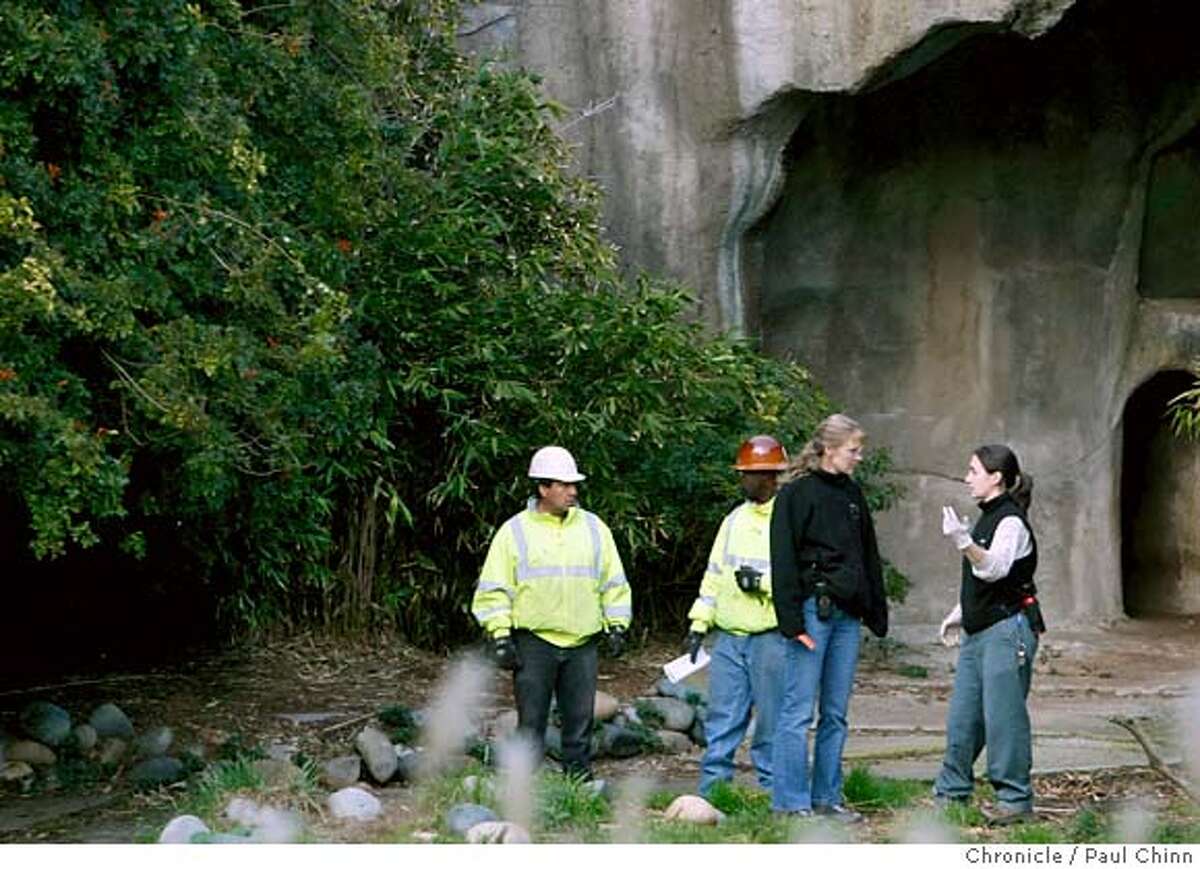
[686,435,787,795]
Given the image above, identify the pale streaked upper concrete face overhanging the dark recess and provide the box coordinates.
[460,0,1073,330]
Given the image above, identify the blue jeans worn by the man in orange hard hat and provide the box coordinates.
[700,630,787,796]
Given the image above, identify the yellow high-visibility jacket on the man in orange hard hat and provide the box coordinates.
[688,498,779,635]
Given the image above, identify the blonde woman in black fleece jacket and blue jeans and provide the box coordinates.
[770,413,888,822]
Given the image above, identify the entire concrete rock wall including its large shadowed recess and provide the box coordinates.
[462,0,1200,621]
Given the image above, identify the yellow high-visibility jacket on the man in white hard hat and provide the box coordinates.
[470,499,634,648]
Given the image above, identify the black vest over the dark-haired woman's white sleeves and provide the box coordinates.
[960,493,1038,634]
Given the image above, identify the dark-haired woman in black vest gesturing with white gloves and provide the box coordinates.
[934,444,1045,823]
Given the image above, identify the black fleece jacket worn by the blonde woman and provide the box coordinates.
[770,469,888,639]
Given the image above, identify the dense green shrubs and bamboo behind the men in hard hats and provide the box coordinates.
[0,0,894,642]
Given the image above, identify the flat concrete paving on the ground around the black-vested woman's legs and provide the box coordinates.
[846,619,1200,779]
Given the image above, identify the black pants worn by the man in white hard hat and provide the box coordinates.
[512,630,599,775]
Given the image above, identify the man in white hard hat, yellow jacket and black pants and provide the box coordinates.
[472,447,632,777]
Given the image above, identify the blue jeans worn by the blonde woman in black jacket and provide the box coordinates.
[772,598,862,811]
